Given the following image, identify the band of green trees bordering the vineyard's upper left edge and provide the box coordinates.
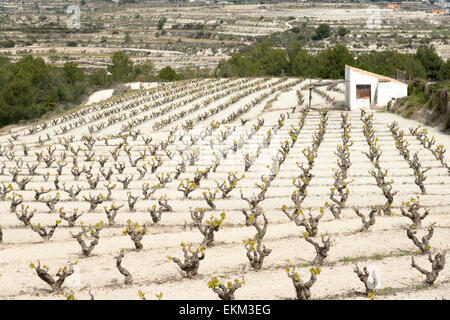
[0,52,155,127]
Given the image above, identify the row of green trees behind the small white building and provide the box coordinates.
[216,40,450,80]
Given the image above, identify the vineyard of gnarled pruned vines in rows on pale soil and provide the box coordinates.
[0,78,450,300]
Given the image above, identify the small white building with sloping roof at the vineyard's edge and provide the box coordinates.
[345,66,408,110]
